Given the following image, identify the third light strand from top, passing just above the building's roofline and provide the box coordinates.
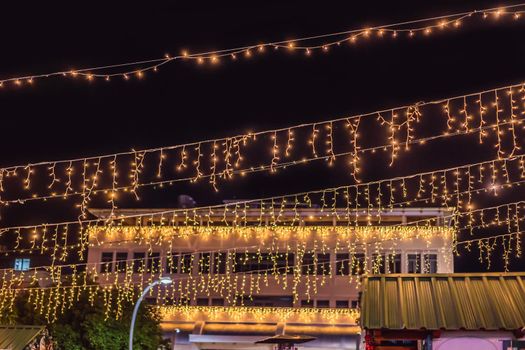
[0,155,525,251]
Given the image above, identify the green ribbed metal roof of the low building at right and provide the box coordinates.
[360,273,525,331]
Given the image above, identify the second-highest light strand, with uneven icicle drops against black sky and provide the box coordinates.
[0,84,525,206]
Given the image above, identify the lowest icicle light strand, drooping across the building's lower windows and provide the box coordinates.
[0,215,524,322]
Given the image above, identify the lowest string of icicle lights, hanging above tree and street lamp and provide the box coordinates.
[0,213,523,322]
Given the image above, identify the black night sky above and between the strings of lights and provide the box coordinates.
[0,1,525,272]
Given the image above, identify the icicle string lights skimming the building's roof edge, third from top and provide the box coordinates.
[0,150,525,255]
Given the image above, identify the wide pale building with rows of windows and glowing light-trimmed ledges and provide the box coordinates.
[87,208,454,349]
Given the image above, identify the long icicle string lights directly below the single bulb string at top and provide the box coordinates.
[0,80,525,218]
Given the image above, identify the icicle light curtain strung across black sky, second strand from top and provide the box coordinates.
[0,80,525,206]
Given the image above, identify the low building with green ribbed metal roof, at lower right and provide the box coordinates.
[361,272,525,350]
